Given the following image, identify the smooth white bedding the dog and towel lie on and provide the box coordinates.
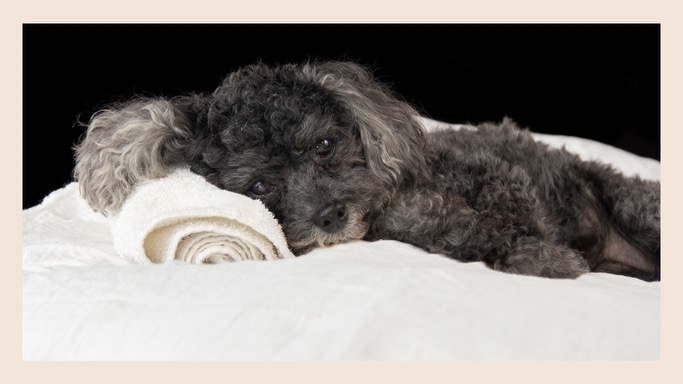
[23,119,660,360]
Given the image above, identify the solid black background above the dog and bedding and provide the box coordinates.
[22,24,660,208]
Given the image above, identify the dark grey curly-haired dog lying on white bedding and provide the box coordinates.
[74,61,660,281]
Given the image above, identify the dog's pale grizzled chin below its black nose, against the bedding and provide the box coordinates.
[285,207,369,255]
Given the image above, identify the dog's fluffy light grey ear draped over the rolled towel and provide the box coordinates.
[74,95,200,215]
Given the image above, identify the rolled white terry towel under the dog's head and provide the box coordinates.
[111,168,294,264]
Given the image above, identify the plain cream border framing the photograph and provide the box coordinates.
[6,0,683,384]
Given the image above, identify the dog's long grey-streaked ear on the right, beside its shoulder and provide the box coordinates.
[309,62,426,188]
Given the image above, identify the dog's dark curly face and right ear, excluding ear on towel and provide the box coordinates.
[75,62,426,253]
